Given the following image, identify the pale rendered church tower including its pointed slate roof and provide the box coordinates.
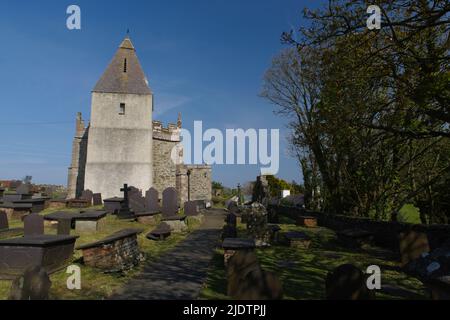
[84,37,153,198]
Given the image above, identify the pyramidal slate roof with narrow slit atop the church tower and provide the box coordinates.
[92,36,152,94]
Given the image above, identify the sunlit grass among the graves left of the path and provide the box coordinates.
[0,207,199,300]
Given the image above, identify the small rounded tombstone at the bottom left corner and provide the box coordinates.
[8,266,52,300]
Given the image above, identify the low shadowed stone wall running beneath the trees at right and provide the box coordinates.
[268,205,450,251]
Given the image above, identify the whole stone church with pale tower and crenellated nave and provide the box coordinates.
[68,36,211,204]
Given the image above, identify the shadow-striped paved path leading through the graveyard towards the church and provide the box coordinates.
[110,209,225,300]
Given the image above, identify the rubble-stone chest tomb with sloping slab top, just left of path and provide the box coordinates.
[76,229,143,272]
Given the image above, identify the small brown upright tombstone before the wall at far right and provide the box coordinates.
[399,230,430,267]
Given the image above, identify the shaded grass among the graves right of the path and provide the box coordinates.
[200,218,428,300]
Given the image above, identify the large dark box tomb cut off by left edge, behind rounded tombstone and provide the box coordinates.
[0,235,78,279]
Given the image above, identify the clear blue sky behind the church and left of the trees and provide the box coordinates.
[0,0,319,186]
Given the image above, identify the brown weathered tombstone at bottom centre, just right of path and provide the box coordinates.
[227,251,283,300]
